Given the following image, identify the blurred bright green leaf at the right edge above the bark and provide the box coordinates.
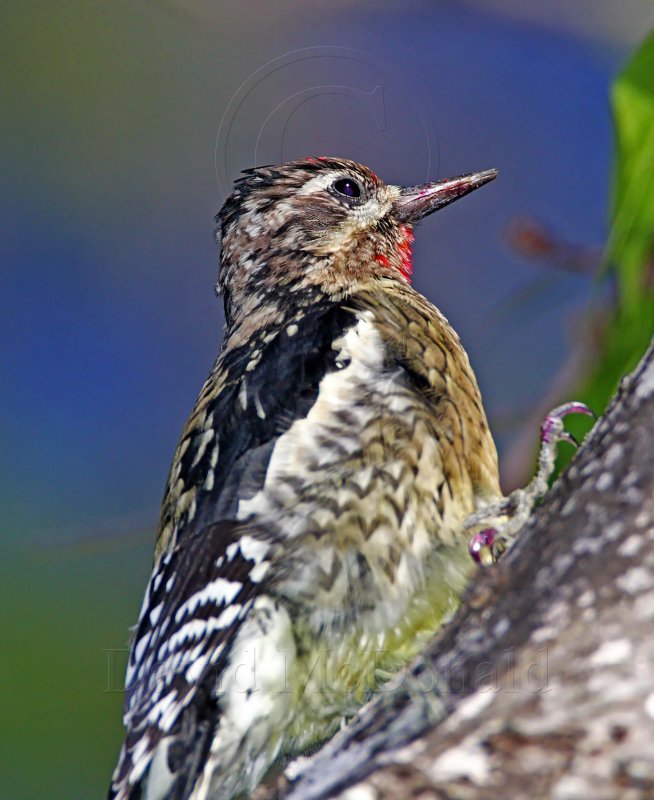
[564,32,654,446]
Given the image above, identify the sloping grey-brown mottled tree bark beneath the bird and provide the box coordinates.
[257,336,654,800]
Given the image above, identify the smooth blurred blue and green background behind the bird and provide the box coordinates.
[0,0,654,800]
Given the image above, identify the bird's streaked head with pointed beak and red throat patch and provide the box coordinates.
[218,158,497,322]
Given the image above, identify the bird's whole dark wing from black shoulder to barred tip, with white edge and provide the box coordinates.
[111,303,364,800]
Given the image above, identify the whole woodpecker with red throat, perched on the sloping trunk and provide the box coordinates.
[109,158,596,800]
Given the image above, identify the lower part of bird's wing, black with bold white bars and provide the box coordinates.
[110,523,269,800]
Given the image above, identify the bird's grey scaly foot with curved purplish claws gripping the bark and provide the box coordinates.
[464,402,596,565]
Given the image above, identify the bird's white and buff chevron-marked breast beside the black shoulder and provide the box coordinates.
[238,312,474,635]
